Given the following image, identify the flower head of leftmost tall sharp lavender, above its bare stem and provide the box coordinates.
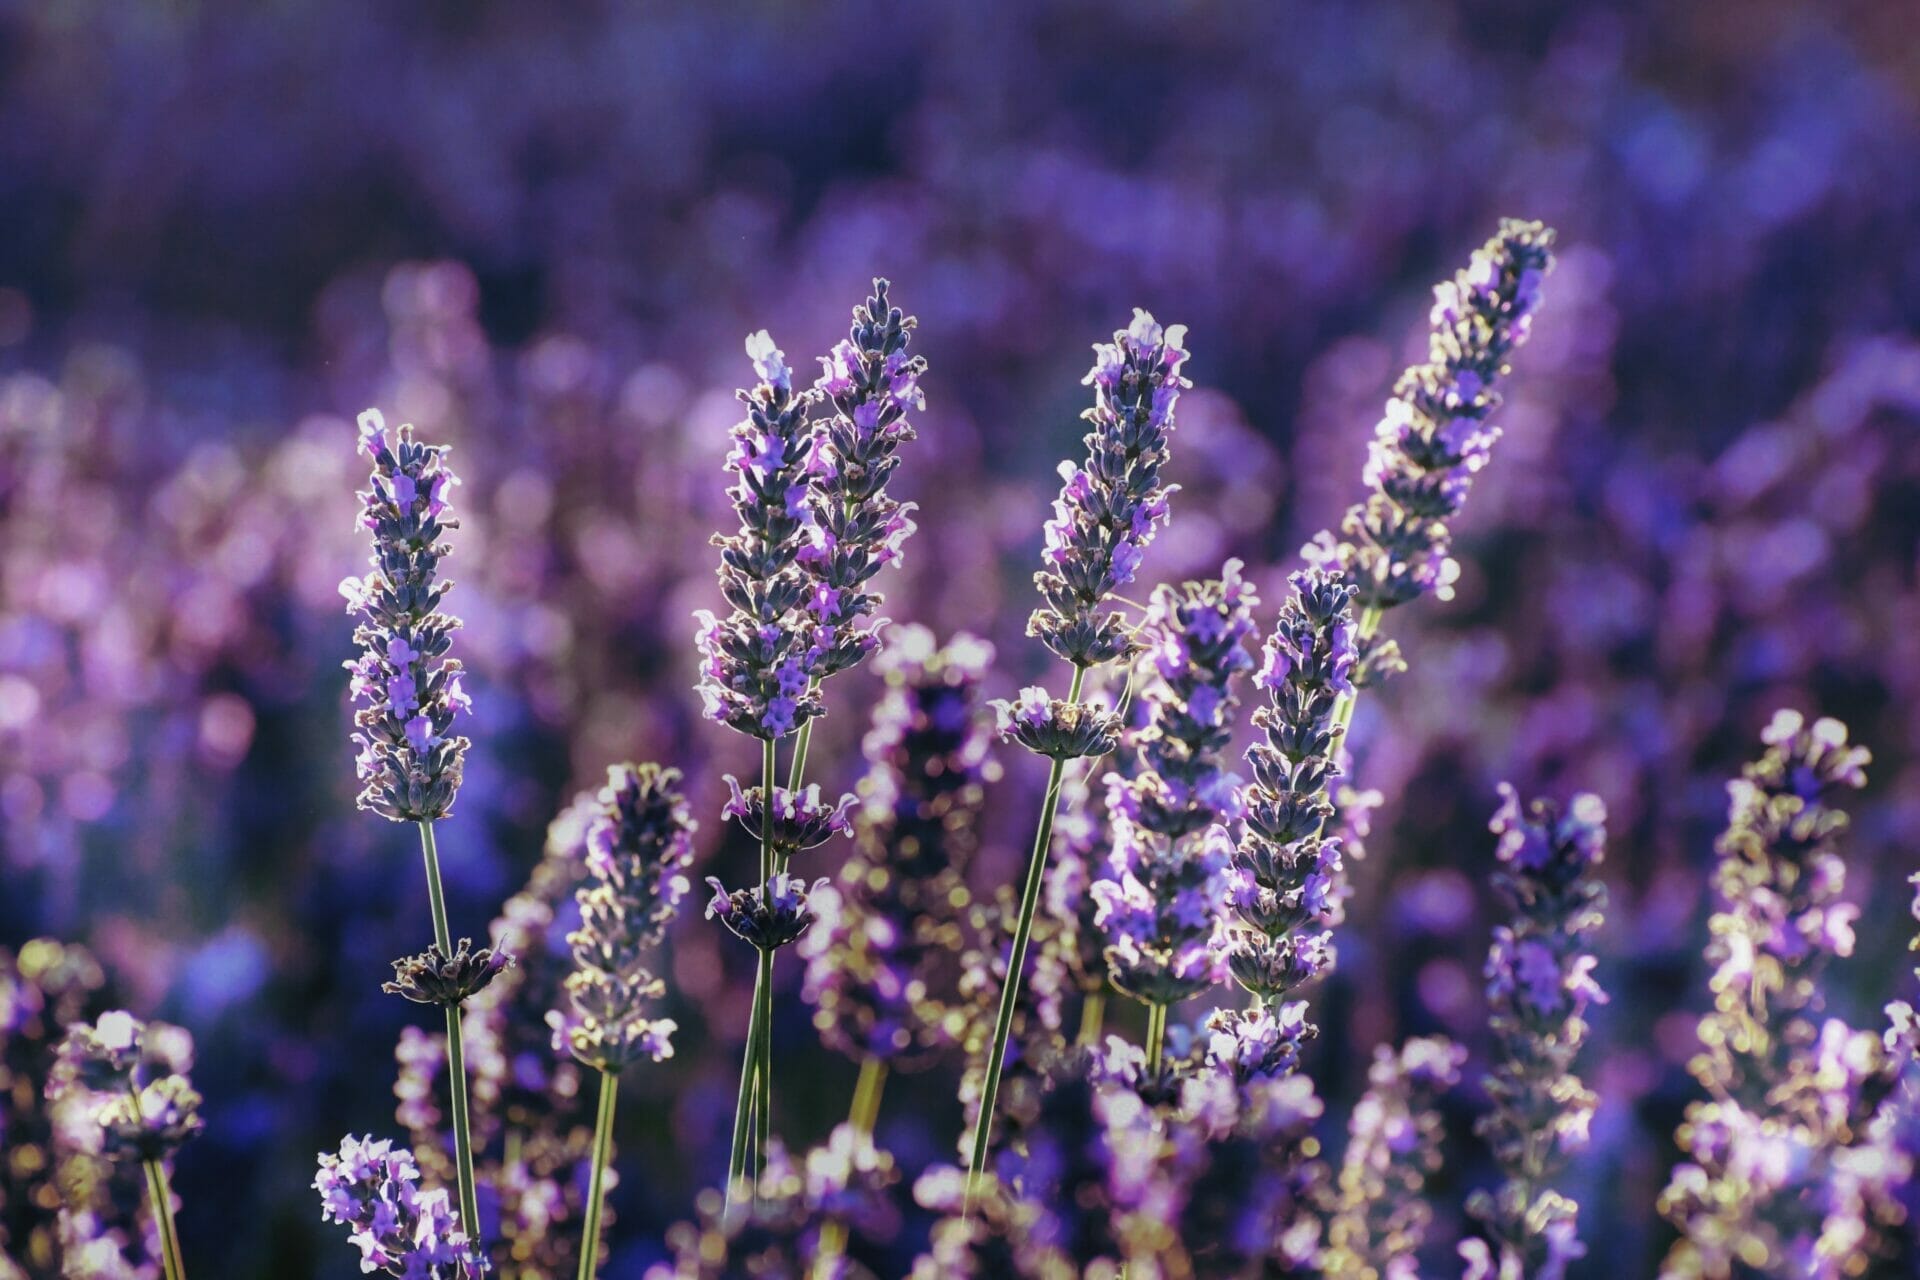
[340,409,472,821]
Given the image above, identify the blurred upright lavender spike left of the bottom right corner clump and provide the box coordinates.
[1461,783,1607,1280]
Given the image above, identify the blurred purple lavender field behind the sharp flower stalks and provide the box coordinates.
[0,0,1920,1280]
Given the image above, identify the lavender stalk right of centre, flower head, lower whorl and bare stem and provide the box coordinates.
[968,311,1188,1188]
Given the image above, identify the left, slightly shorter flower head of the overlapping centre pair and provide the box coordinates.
[695,330,824,739]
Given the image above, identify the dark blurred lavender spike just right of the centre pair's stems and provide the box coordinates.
[799,626,993,1063]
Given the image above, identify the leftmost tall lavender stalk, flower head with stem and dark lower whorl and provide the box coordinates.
[340,409,509,1234]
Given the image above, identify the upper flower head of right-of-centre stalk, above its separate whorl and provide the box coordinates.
[1027,311,1190,671]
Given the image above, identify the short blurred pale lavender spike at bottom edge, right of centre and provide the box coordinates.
[1319,1036,1467,1280]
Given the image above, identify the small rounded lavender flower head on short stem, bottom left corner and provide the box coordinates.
[46,1009,205,1163]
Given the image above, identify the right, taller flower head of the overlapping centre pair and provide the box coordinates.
[801,278,927,679]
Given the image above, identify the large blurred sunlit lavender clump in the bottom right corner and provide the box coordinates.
[1661,710,1912,1280]
